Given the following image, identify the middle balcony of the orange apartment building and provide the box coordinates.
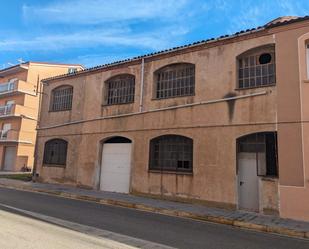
[0,104,37,119]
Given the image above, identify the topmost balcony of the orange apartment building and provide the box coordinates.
[0,80,37,97]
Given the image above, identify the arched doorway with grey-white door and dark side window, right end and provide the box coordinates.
[237,132,278,211]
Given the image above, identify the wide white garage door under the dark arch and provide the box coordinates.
[100,143,131,193]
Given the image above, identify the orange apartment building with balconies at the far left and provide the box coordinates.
[0,62,83,171]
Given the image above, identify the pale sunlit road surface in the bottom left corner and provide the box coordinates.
[0,210,135,249]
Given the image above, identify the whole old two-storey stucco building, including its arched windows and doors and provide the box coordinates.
[36,17,309,220]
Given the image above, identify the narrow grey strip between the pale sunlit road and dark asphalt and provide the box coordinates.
[0,203,176,249]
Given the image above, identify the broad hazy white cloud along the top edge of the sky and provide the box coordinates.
[23,0,188,24]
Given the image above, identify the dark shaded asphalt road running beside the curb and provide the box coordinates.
[0,188,309,249]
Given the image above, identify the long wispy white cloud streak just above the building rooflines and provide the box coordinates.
[0,28,184,51]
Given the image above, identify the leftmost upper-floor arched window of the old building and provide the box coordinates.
[50,86,73,111]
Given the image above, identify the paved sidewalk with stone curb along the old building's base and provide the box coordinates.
[0,178,309,239]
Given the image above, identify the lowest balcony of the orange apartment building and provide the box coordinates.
[0,130,35,144]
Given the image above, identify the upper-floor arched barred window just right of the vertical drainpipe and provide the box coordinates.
[155,63,195,99]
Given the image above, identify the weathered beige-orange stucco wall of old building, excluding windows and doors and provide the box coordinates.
[36,16,309,220]
